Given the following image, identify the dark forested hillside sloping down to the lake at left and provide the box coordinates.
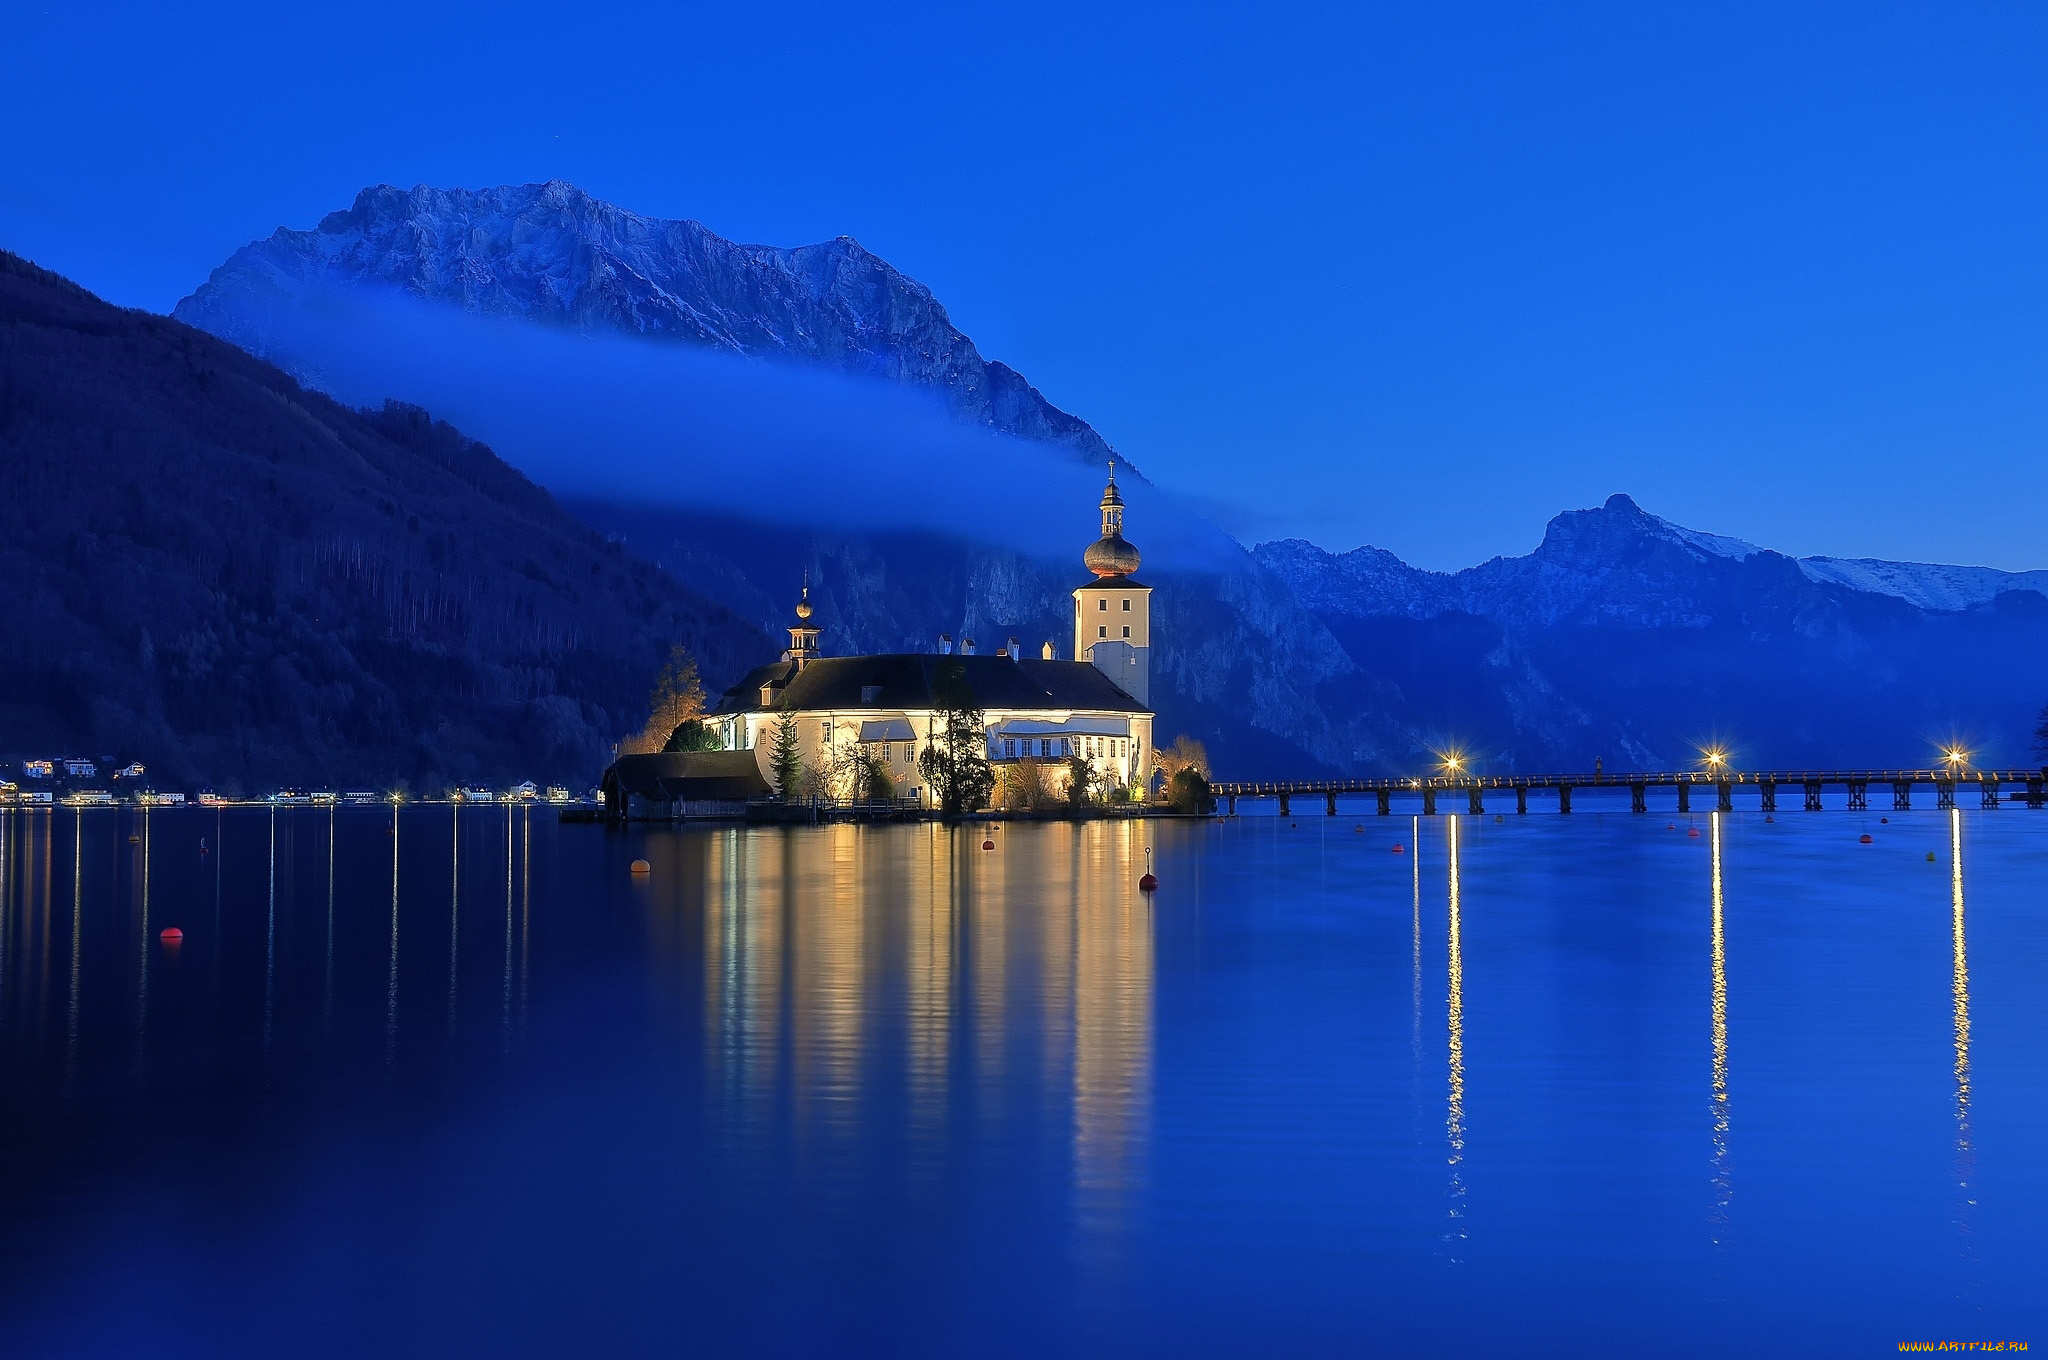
[0,252,772,787]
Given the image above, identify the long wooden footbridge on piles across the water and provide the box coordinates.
[1210,768,2048,817]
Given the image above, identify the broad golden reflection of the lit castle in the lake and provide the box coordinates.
[647,821,1153,1221]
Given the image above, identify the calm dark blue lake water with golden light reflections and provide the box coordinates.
[0,807,2048,1356]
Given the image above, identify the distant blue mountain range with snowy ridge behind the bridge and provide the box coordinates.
[1253,496,2048,770]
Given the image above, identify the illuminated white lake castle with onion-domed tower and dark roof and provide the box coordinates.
[606,465,1155,811]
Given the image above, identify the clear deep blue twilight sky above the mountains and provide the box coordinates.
[0,0,2048,567]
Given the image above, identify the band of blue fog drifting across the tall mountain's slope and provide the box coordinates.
[244,291,1247,571]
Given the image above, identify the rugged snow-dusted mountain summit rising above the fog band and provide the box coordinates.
[172,180,1112,465]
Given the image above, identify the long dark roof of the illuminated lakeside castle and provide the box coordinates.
[715,653,1151,713]
